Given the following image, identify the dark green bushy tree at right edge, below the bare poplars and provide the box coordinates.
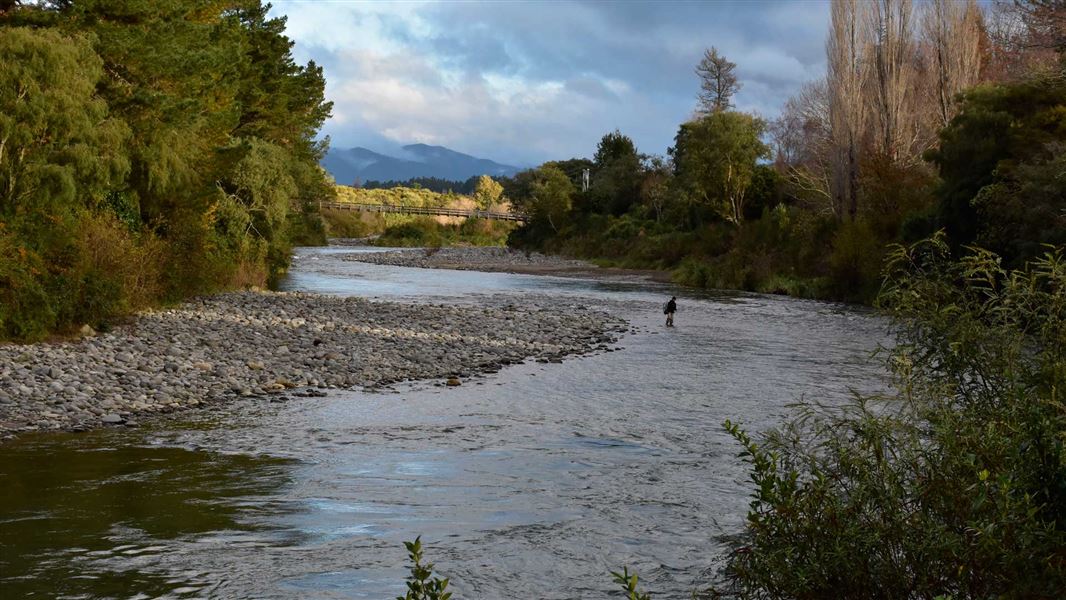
[928,73,1066,264]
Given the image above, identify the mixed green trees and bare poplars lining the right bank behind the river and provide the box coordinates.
[503,0,1066,302]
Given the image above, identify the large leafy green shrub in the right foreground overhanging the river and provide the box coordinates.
[723,236,1066,598]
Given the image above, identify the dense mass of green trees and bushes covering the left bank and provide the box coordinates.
[0,0,333,339]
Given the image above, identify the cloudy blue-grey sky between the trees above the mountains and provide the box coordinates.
[272,0,829,166]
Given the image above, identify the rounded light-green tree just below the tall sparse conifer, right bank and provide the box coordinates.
[673,112,770,226]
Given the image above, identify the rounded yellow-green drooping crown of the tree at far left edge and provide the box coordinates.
[0,28,129,218]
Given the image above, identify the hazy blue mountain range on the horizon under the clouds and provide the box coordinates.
[322,144,521,185]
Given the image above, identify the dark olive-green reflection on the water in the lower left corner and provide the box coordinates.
[0,433,293,598]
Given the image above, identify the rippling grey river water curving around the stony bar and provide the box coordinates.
[0,247,887,599]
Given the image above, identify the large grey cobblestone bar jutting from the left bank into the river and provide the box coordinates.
[0,292,624,438]
